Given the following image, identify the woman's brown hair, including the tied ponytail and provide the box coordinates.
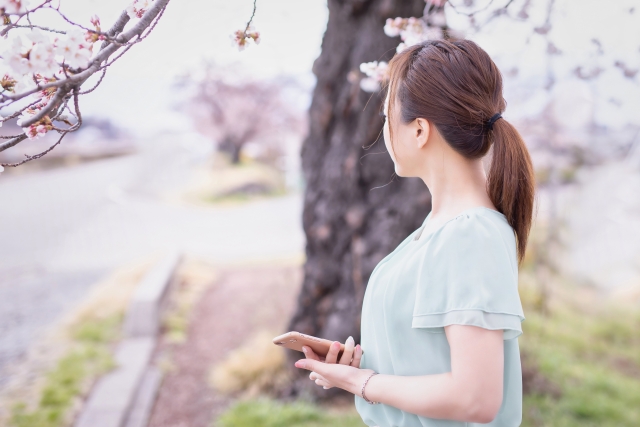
[388,40,535,262]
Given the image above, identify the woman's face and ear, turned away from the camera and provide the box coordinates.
[383,96,430,177]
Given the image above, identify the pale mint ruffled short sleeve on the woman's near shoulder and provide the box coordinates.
[411,210,525,340]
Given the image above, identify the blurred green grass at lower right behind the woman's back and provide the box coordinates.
[520,284,640,427]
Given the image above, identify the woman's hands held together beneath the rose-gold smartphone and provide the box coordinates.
[295,337,373,396]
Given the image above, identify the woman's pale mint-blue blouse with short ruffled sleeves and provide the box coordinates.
[355,206,525,427]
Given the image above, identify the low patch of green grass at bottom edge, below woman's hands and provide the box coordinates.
[213,398,365,427]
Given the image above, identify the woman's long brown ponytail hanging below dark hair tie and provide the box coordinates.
[487,119,535,262]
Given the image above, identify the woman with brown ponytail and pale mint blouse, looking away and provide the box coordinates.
[296,40,534,427]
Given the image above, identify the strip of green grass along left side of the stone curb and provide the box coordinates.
[10,315,122,427]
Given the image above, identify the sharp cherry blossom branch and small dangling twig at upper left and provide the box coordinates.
[0,0,260,172]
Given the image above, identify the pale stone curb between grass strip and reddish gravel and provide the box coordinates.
[74,252,181,427]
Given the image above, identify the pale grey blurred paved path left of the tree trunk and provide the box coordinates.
[0,136,304,388]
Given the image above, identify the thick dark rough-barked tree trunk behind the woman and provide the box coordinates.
[288,0,431,397]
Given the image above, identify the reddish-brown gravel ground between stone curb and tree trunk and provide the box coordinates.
[149,265,302,427]
